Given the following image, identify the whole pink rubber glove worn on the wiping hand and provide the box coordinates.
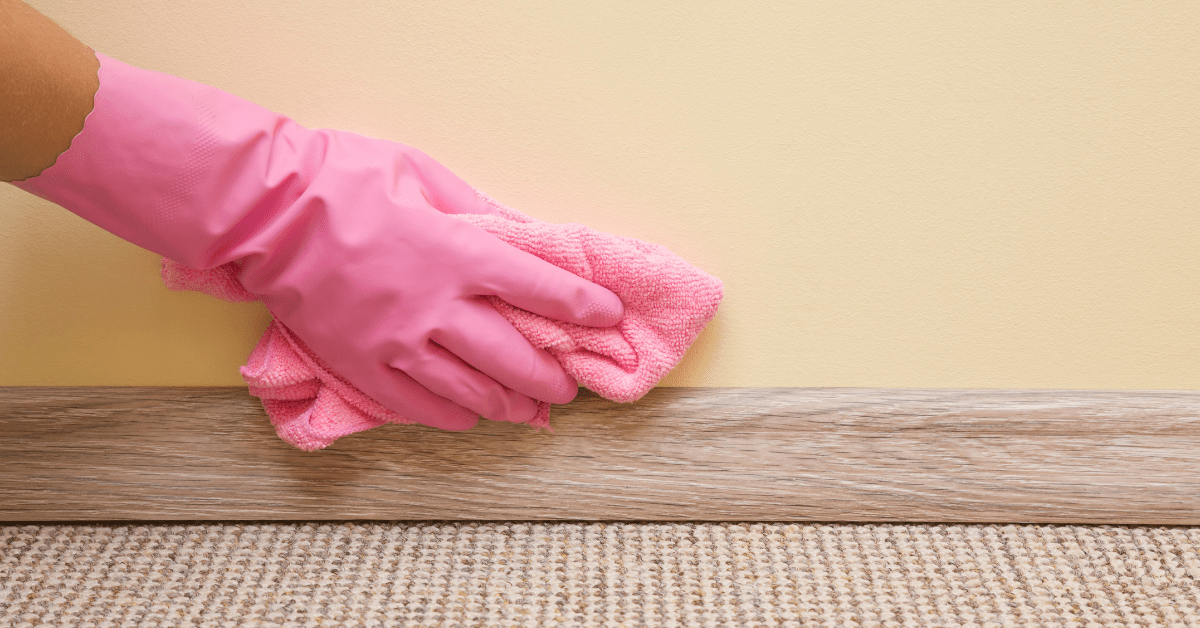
[13,53,623,430]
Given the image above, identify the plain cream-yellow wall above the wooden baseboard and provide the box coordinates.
[0,0,1200,389]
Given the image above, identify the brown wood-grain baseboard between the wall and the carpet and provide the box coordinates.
[0,387,1200,525]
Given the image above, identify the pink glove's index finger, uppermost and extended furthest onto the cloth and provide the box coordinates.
[478,238,625,327]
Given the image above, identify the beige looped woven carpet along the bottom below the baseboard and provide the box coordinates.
[0,522,1200,627]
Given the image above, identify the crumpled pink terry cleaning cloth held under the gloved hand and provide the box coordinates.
[162,192,724,451]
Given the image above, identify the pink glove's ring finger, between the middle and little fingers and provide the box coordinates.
[391,341,538,423]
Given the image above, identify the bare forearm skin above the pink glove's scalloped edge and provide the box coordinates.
[0,0,100,181]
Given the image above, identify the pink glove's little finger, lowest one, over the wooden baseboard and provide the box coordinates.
[352,363,479,431]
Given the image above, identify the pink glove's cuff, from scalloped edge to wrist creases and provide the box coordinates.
[13,53,324,270]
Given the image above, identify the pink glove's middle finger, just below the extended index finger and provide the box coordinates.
[430,297,580,403]
